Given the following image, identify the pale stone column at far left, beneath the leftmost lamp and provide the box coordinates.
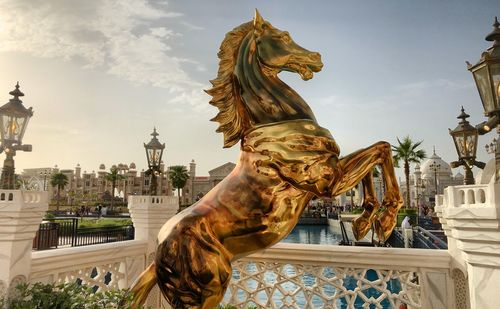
[0,190,49,296]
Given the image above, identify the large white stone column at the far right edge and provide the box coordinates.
[436,181,500,309]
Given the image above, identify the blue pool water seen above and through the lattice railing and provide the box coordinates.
[226,225,401,309]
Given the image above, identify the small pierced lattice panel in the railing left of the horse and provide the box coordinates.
[57,262,125,291]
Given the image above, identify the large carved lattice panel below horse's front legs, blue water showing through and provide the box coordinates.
[224,261,421,309]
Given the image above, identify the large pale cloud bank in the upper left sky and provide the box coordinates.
[0,0,207,110]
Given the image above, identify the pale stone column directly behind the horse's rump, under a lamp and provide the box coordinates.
[128,195,179,308]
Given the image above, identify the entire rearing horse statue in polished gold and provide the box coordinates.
[131,12,403,309]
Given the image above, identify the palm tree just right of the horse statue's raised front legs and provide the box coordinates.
[392,135,425,207]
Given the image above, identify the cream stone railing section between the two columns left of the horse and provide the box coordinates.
[30,240,147,291]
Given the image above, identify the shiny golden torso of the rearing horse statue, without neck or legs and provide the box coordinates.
[159,121,338,259]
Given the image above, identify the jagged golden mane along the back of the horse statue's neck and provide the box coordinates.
[206,22,253,148]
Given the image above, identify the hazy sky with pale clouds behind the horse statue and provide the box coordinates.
[0,0,500,175]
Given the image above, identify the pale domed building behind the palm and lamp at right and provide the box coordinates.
[400,149,464,207]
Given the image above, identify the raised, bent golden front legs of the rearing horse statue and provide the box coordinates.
[332,142,403,241]
